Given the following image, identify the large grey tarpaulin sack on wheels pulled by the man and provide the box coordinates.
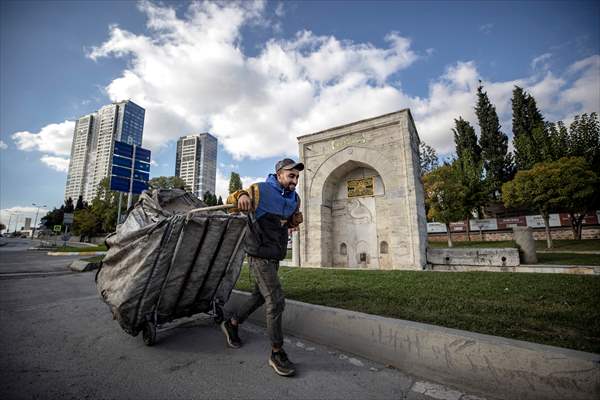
[96,189,247,344]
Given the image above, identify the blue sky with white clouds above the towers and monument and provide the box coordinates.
[0,1,600,230]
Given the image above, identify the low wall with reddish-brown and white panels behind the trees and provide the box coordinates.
[428,226,600,242]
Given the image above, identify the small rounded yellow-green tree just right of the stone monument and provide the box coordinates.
[423,164,466,247]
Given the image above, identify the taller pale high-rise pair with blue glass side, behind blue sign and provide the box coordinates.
[65,100,145,202]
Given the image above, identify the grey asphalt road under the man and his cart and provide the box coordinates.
[0,239,486,400]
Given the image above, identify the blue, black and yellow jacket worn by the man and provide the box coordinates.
[227,174,300,260]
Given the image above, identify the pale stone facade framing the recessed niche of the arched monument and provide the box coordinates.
[294,109,427,269]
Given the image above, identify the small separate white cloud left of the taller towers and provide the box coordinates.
[11,121,75,156]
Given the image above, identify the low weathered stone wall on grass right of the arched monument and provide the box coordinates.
[427,248,520,267]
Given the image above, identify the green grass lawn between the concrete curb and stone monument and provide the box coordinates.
[237,266,600,353]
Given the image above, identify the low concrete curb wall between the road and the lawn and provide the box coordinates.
[226,291,600,400]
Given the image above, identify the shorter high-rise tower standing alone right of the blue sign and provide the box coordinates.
[175,133,217,198]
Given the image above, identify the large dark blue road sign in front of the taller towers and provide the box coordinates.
[110,141,151,194]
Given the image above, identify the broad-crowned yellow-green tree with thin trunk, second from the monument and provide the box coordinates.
[502,162,568,249]
